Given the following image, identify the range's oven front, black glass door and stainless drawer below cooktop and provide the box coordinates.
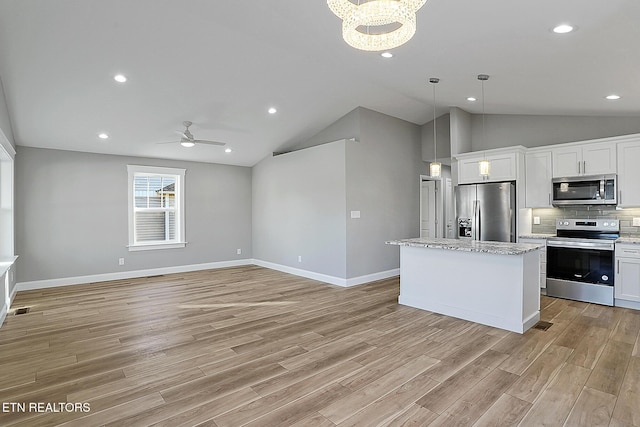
[547,238,615,305]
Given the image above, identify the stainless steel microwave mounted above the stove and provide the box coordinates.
[553,175,618,206]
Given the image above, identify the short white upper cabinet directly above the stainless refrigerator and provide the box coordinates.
[458,152,518,184]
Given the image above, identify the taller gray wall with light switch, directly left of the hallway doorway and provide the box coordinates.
[347,108,428,278]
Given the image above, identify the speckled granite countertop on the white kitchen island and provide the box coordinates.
[385,237,542,255]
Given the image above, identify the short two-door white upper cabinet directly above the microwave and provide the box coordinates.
[551,142,616,178]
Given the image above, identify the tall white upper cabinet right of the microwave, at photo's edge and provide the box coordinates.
[618,138,640,207]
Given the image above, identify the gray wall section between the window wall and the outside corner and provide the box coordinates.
[253,140,348,278]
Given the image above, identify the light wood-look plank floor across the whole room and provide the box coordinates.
[0,266,640,427]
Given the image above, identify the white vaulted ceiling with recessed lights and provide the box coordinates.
[0,0,640,166]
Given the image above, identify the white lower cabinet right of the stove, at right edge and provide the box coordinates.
[614,243,640,308]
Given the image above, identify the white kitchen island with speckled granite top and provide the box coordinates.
[386,238,541,333]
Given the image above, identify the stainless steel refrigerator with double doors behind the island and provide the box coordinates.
[456,182,516,242]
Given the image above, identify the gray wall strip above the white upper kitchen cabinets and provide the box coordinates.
[468,114,640,152]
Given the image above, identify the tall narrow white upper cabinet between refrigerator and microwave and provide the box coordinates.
[524,150,552,208]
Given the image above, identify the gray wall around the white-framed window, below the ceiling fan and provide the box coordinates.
[15,146,252,282]
